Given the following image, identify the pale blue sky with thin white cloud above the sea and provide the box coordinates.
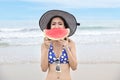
[0,0,120,26]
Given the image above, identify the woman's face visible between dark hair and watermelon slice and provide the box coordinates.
[51,17,65,29]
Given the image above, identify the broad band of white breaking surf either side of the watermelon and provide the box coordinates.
[0,28,120,46]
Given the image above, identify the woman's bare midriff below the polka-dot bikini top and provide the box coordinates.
[46,64,71,80]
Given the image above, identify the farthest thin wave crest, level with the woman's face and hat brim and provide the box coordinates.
[0,26,120,32]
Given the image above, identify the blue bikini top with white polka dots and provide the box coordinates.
[48,44,69,64]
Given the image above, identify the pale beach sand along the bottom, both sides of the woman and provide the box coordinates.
[0,63,120,80]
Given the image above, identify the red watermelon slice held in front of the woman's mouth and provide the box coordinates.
[44,28,70,40]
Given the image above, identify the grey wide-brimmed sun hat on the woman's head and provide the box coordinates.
[39,10,80,36]
